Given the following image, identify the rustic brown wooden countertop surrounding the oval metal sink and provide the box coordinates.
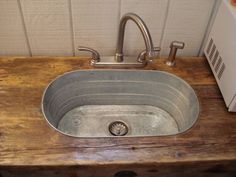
[0,57,236,167]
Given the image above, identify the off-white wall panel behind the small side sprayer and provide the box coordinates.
[161,0,215,56]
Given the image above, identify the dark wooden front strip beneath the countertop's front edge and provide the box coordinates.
[1,161,236,177]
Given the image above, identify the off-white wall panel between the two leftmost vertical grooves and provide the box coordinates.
[21,0,73,56]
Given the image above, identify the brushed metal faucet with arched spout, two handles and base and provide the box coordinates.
[78,13,160,67]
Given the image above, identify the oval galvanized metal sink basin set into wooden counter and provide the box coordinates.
[42,70,199,137]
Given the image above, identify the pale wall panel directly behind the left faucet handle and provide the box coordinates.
[72,0,119,55]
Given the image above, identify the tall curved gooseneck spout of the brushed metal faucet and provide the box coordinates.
[115,13,155,62]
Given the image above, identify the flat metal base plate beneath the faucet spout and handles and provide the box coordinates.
[91,56,147,68]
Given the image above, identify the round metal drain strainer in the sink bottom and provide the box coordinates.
[109,121,129,136]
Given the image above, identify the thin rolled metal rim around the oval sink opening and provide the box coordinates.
[41,69,201,139]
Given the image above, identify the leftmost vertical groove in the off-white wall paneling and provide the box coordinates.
[17,0,33,57]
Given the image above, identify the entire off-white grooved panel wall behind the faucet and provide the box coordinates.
[0,0,216,56]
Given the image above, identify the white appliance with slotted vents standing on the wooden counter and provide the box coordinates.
[204,0,236,112]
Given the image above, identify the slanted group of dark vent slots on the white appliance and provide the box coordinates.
[206,39,226,80]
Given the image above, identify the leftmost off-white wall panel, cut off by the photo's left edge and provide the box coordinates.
[0,0,30,56]
